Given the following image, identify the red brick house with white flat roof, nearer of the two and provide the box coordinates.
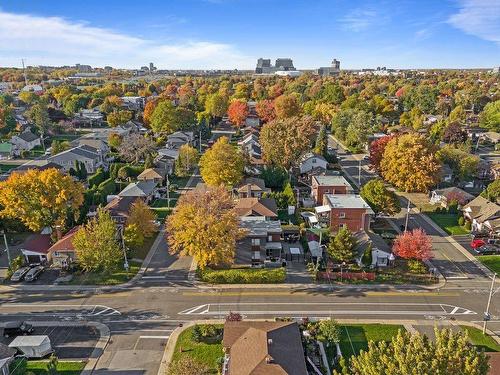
[315,194,374,232]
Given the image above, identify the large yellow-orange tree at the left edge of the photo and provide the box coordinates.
[0,168,84,232]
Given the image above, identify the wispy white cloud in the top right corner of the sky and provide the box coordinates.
[448,0,500,43]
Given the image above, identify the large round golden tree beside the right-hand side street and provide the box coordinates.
[380,134,441,192]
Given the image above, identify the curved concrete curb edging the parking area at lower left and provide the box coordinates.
[29,320,111,375]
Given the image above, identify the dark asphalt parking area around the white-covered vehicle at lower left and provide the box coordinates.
[1,327,99,360]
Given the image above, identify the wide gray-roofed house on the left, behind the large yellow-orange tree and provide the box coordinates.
[48,145,106,173]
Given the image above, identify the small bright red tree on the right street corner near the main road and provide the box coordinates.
[392,229,432,260]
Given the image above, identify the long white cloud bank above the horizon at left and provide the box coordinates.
[0,10,253,69]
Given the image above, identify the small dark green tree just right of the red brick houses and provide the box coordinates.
[360,179,401,215]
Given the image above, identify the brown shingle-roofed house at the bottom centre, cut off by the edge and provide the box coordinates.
[222,321,308,375]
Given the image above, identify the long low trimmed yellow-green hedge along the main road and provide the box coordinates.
[198,267,286,284]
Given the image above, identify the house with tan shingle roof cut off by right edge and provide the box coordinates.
[462,196,500,232]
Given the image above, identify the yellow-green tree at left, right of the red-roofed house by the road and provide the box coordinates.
[73,209,123,273]
